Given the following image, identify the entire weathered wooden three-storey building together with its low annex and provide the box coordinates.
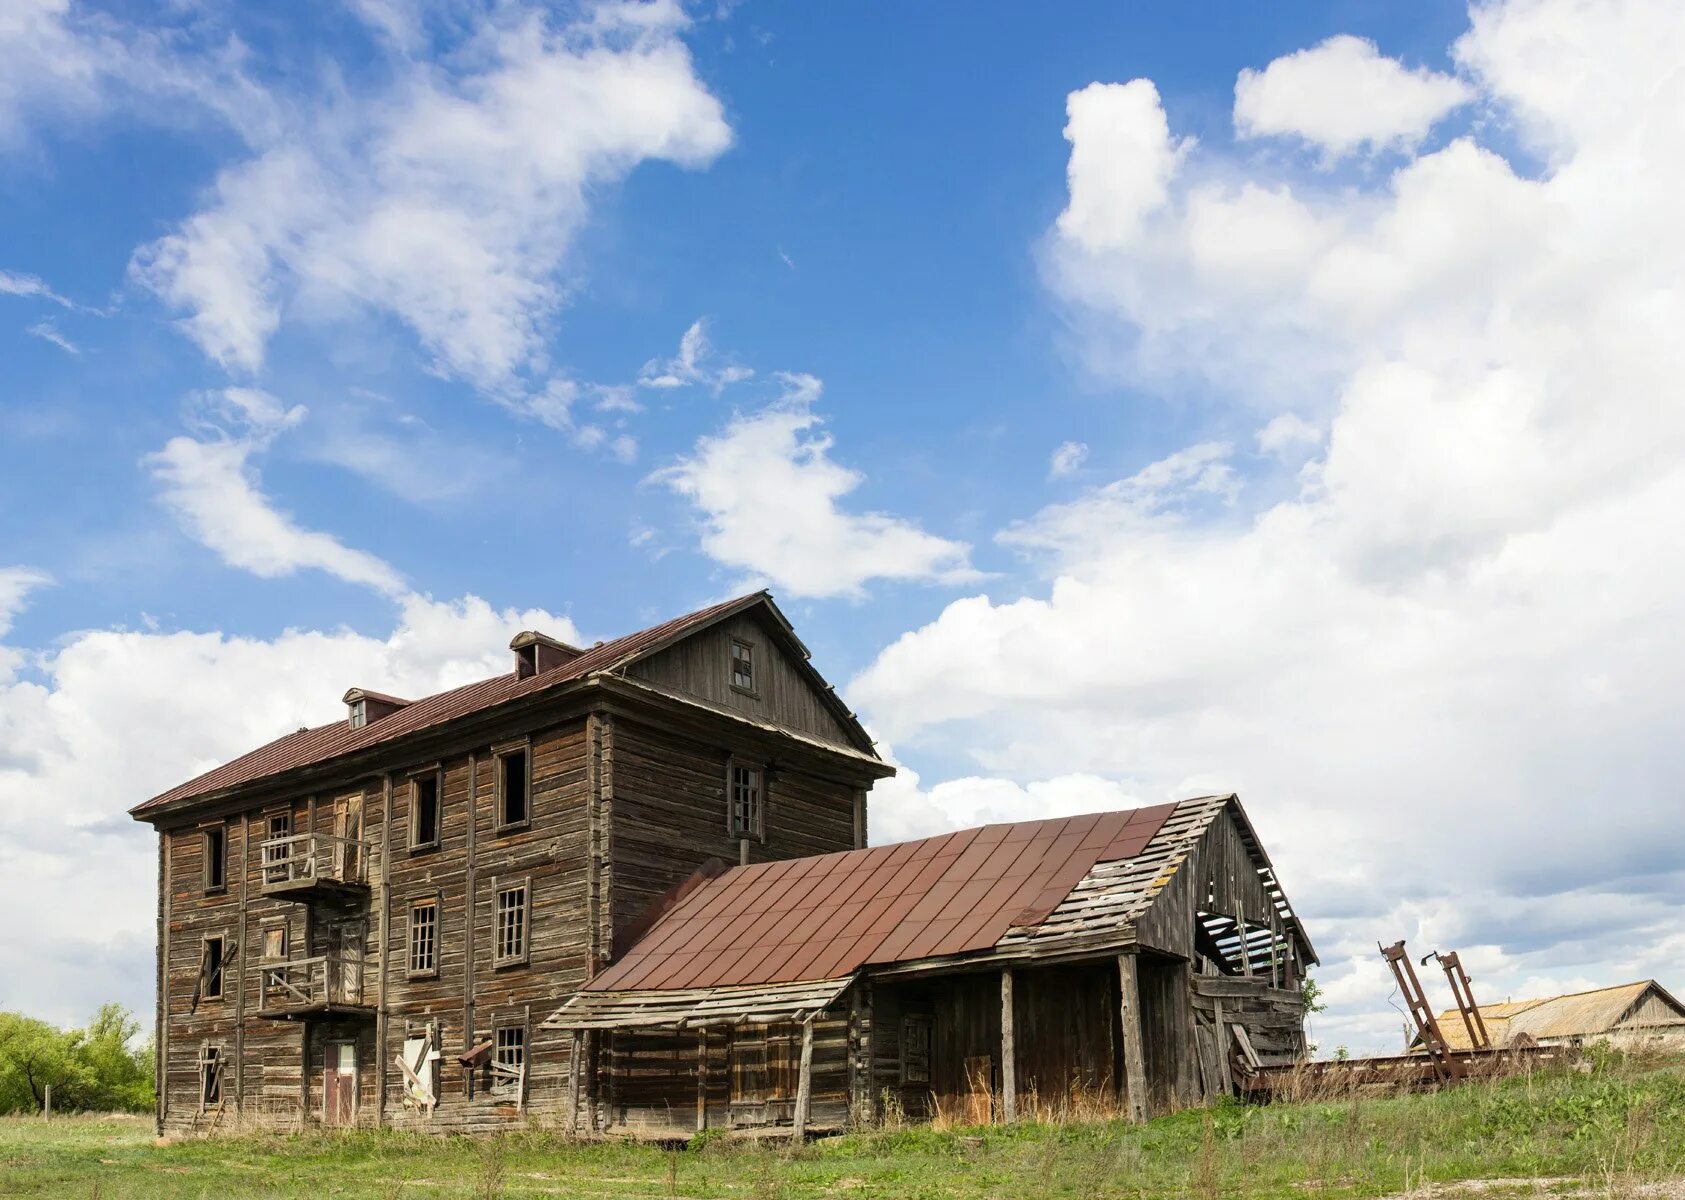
[133,593,1314,1136]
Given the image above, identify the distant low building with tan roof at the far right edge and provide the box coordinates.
[1410,979,1685,1053]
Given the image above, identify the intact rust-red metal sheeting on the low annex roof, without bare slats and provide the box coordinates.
[586,804,1176,991]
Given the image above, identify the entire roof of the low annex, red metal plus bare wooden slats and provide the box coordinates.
[549,796,1314,1028]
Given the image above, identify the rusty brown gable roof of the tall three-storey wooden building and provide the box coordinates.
[130,592,875,819]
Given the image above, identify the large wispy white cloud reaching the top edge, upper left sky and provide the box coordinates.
[133,3,731,397]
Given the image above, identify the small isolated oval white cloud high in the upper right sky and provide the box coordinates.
[1235,34,1474,158]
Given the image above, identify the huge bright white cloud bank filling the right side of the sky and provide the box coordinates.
[849,0,1685,1048]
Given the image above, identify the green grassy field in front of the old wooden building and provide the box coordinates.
[0,1069,1685,1200]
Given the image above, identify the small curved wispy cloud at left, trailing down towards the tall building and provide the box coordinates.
[147,388,404,597]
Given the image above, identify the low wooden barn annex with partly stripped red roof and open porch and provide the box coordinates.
[544,796,1316,1136]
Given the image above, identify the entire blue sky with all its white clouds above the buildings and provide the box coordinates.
[0,0,1685,1047]
